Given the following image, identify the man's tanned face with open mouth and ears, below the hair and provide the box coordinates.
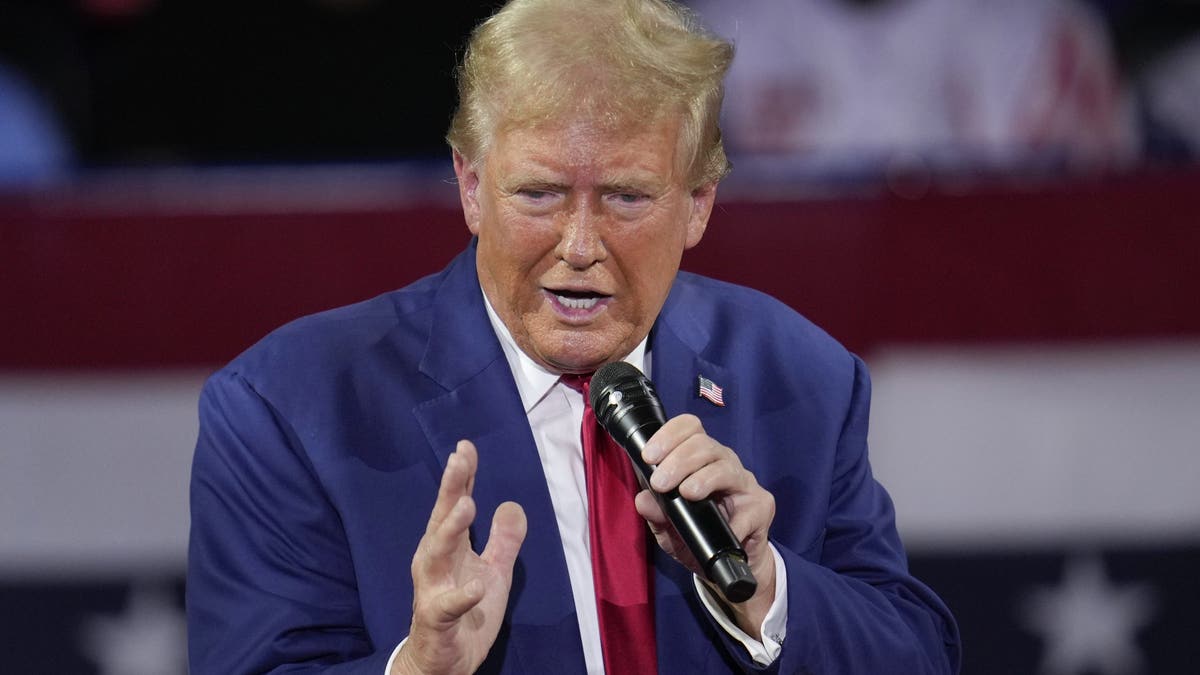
[455,112,716,372]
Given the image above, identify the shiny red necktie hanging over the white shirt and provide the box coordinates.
[563,375,658,675]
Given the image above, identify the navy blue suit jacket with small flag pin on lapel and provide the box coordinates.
[187,239,958,675]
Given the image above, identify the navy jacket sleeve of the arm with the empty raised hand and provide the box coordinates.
[187,371,395,675]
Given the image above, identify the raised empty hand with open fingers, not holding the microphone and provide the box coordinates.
[392,441,527,675]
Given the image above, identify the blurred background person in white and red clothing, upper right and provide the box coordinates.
[691,0,1139,174]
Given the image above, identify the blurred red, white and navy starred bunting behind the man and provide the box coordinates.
[0,166,1200,675]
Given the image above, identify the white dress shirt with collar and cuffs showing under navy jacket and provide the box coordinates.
[388,290,787,675]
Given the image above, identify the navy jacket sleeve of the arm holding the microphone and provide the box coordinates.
[705,357,960,675]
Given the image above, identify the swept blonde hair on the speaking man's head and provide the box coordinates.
[446,0,733,187]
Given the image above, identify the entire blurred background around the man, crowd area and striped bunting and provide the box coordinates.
[0,0,1200,675]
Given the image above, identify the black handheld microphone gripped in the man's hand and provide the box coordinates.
[589,362,758,603]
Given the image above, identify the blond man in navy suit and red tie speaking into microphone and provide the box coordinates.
[187,0,958,675]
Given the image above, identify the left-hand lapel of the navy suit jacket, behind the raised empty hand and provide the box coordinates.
[413,246,583,671]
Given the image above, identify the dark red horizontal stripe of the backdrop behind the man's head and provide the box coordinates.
[0,172,1200,370]
